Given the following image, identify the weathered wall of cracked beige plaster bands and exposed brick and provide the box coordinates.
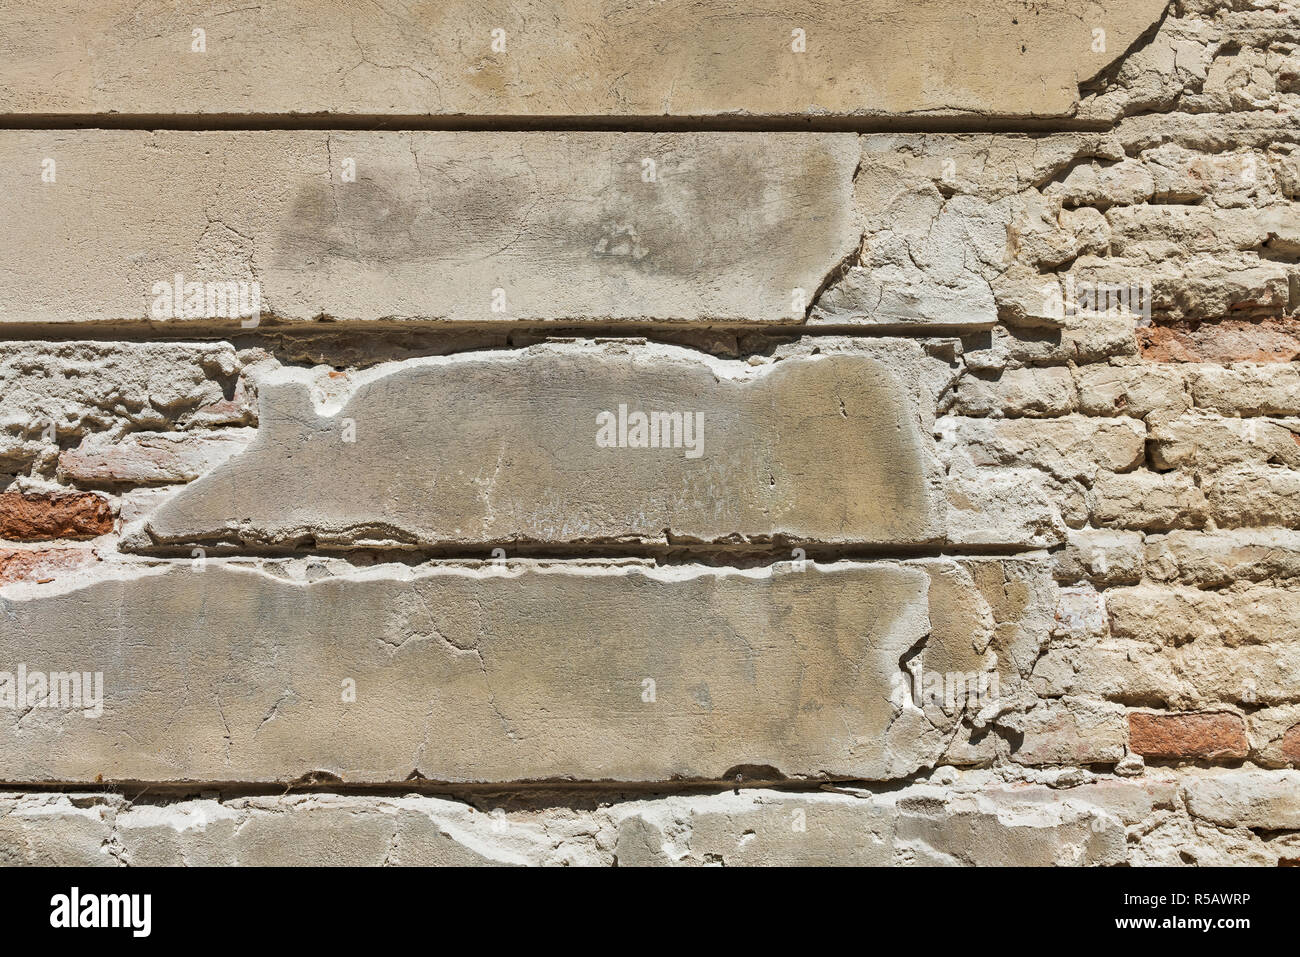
[0,0,1300,866]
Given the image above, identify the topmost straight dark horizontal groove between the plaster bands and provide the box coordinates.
[0,113,1112,134]
